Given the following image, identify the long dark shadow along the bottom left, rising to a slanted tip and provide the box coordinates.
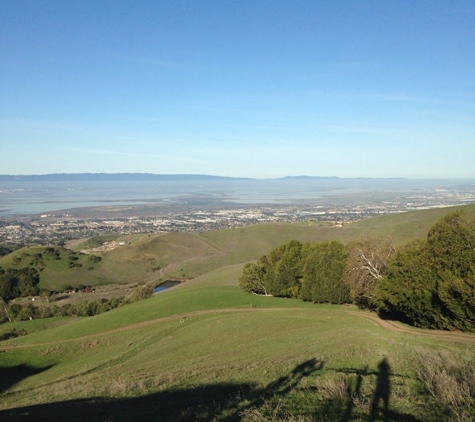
[0,359,416,422]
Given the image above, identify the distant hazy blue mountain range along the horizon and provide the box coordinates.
[0,173,338,182]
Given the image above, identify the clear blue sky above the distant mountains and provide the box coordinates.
[0,0,475,178]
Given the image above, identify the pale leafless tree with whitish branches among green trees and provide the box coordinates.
[344,237,396,309]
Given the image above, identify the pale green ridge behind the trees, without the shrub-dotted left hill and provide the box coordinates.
[96,201,475,281]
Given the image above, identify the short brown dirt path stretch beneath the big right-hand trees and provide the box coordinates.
[347,311,475,344]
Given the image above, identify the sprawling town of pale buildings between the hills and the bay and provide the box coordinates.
[0,191,475,244]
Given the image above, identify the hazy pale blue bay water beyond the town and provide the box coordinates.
[0,178,475,218]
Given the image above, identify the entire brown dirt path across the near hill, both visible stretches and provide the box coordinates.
[0,308,475,351]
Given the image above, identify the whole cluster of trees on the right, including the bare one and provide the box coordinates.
[239,211,475,331]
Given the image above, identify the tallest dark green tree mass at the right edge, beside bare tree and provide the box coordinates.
[378,212,475,331]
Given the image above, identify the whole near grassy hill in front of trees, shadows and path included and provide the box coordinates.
[0,258,475,421]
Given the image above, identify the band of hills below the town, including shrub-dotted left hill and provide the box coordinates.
[0,205,475,290]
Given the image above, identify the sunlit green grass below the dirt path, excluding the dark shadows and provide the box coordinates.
[2,295,474,420]
